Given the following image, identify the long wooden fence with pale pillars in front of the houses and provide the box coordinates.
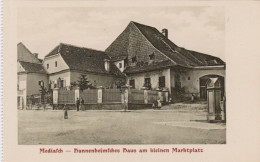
[53,89,168,104]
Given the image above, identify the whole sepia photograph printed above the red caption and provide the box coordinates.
[16,5,228,145]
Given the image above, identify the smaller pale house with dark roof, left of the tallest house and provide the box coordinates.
[43,43,125,88]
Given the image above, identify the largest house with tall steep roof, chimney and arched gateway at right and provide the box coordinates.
[105,22,225,99]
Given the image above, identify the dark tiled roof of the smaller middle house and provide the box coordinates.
[45,43,124,77]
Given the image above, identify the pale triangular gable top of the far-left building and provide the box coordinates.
[17,42,40,63]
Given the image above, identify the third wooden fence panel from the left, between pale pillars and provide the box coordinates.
[102,89,122,103]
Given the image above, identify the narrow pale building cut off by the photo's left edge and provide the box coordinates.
[17,43,48,108]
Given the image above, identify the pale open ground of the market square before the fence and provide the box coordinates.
[18,103,226,145]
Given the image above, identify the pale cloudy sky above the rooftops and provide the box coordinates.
[17,6,225,61]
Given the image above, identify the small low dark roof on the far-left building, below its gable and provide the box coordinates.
[19,61,46,74]
